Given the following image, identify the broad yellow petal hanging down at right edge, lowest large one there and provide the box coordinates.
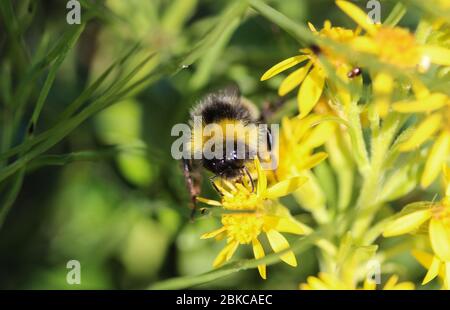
[429,219,450,261]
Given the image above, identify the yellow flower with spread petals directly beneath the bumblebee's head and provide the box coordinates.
[198,159,309,279]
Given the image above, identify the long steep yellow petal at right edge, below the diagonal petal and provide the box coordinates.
[420,131,450,188]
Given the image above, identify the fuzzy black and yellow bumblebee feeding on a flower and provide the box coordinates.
[183,87,272,216]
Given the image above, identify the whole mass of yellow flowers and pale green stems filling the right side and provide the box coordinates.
[199,0,450,289]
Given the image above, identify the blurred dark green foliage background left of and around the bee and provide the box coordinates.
[0,0,421,289]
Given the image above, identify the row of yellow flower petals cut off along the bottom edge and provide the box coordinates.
[300,272,414,290]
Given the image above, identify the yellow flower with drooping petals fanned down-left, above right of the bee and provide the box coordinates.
[261,21,356,118]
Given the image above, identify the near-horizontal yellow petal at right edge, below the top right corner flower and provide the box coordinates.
[392,93,449,113]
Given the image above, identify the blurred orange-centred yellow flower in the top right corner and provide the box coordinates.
[336,0,450,69]
